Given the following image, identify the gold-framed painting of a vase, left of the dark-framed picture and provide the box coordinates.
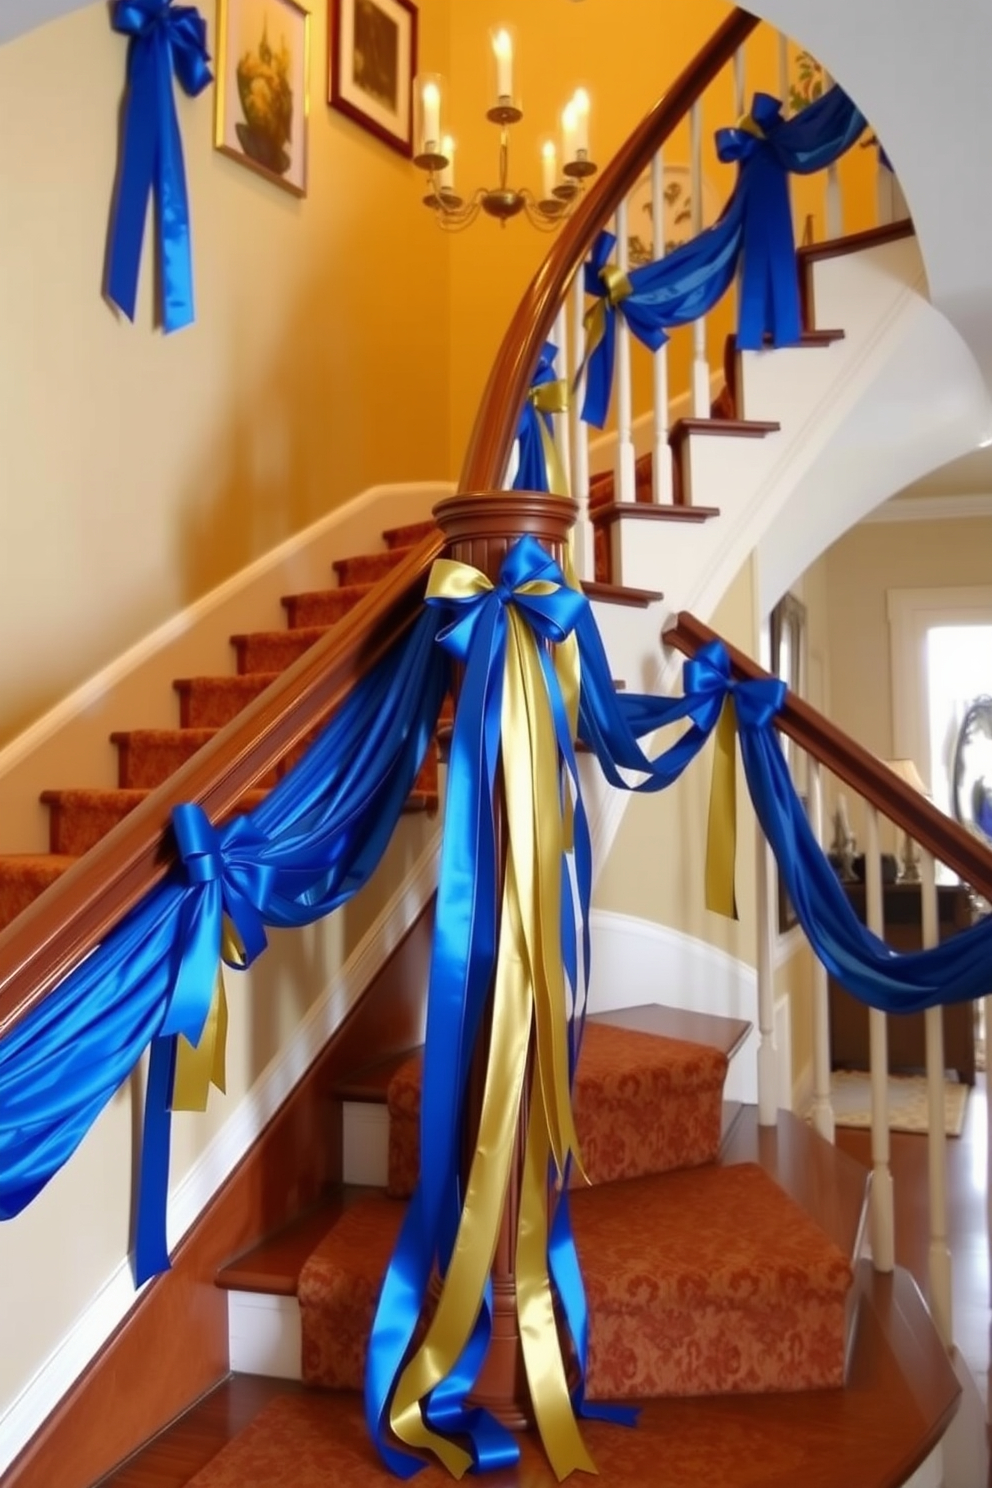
[214,0,309,196]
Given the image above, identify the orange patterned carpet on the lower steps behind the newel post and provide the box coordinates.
[297,1024,852,1400]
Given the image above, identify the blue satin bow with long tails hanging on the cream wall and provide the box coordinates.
[107,0,213,332]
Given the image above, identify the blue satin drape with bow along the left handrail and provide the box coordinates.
[0,610,449,1280]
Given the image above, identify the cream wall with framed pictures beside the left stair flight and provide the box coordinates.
[0,0,452,743]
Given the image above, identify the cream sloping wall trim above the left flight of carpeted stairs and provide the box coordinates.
[0,481,455,777]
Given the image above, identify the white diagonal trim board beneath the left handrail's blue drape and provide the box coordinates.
[0,830,440,1476]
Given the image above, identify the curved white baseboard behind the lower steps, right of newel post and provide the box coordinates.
[589,909,757,1104]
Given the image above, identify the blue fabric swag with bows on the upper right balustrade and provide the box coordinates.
[582,88,864,429]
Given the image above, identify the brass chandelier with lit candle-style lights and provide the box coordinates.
[413,28,596,232]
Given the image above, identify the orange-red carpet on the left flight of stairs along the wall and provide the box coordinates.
[0,522,437,929]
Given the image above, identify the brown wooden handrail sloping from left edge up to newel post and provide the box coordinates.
[0,531,445,1037]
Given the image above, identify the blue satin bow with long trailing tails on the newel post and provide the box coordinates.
[366,537,592,1478]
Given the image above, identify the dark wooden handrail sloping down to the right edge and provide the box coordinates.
[663,610,992,899]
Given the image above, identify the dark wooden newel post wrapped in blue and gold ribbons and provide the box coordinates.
[434,491,577,1430]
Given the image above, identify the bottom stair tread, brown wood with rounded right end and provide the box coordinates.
[143,1262,959,1488]
